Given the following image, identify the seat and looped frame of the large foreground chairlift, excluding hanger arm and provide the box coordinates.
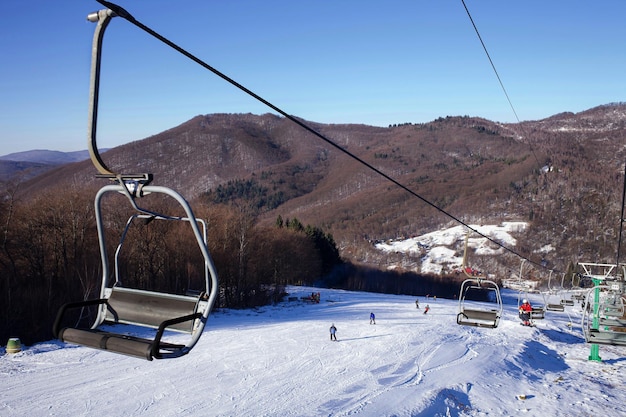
[53,184,217,360]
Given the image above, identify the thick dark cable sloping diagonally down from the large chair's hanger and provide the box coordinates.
[96,0,541,272]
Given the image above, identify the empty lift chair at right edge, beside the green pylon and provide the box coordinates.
[581,283,626,346]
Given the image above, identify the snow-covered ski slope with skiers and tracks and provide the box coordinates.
[0,287,626,417]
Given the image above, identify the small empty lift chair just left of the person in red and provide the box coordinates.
[456,278,502,329]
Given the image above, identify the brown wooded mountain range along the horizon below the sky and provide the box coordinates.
[0,103,626,274]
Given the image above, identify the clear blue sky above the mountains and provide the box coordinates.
[0,0,626,155]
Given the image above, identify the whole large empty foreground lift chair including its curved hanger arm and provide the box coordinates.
[52,2,218,360]
